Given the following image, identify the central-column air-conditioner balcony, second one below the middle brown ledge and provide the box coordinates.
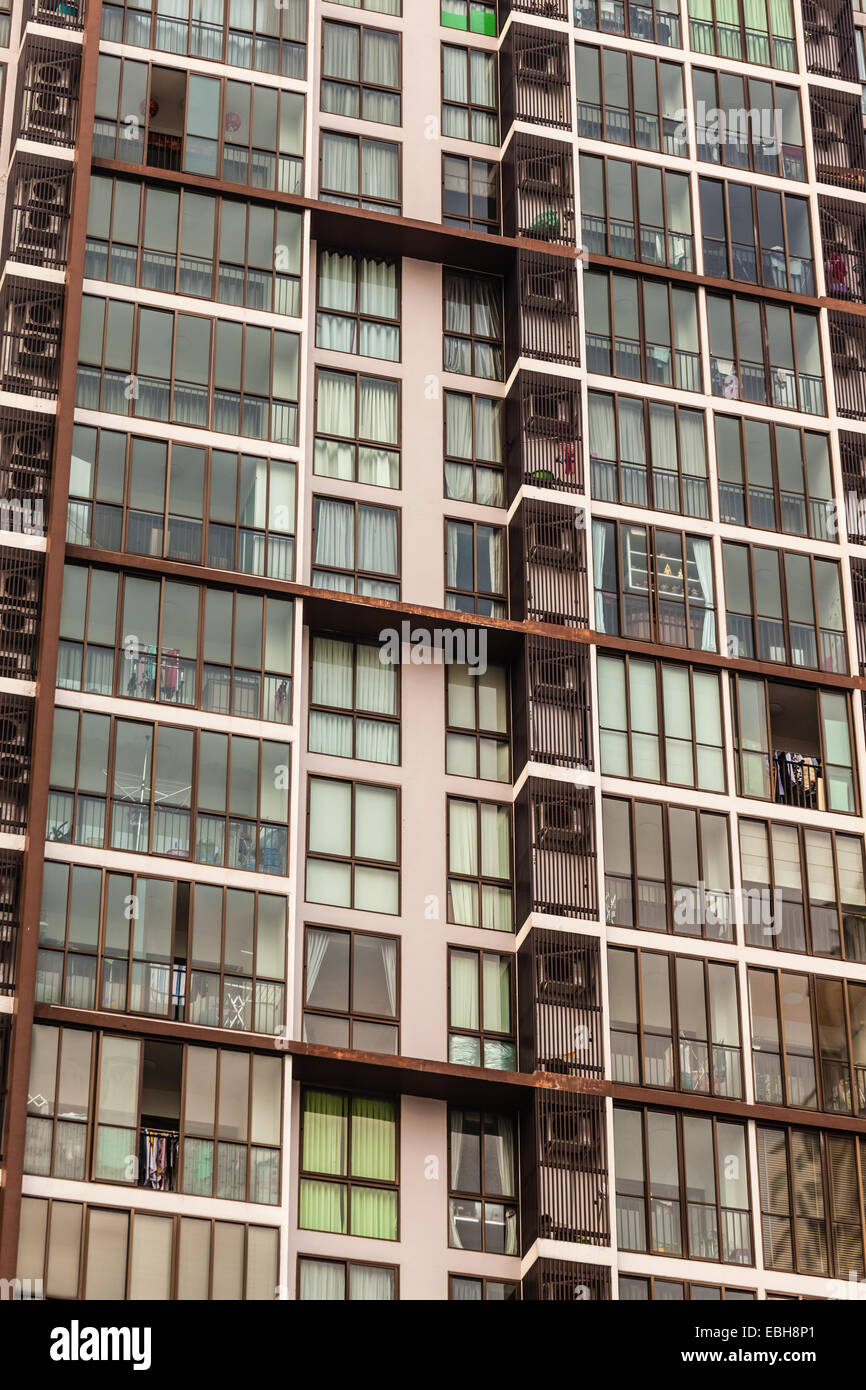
[514,777,598,927]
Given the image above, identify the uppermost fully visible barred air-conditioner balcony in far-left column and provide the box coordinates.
[14,36,81,149]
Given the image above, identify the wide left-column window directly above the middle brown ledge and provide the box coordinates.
[67,425,296,580]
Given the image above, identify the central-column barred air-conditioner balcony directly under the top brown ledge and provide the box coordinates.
[506,252,580,371]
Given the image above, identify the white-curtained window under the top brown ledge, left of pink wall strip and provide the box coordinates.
[316,252,400,361]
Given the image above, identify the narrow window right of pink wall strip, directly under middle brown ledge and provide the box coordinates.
[445,662,510,781]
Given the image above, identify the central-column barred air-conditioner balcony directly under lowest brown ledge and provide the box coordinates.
[520,1091,610,1250]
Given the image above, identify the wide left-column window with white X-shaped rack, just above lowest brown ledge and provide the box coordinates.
[36,859,286,1034]
